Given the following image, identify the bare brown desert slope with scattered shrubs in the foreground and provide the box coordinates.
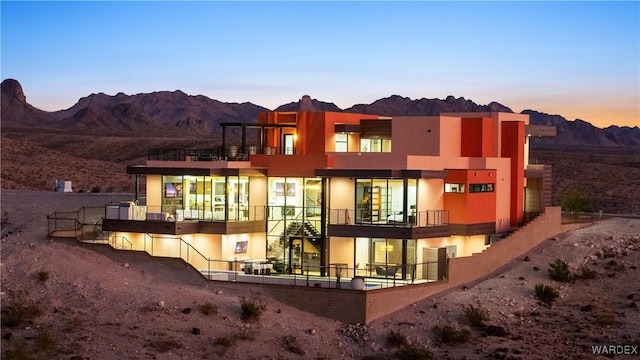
[0,190,640,360]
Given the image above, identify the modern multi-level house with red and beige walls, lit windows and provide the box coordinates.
[102,112,550,282]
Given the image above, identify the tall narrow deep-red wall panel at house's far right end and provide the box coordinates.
[500,121,525,226]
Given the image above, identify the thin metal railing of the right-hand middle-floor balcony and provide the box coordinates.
[329,209,449,227]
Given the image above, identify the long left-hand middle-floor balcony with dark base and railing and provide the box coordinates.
[102,202,266,235]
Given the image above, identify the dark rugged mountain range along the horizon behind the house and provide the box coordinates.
[1,79,640,147]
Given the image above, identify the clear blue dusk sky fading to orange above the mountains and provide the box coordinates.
[0,1,640,127]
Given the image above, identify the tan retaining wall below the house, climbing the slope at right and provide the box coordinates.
[265,207,589,324]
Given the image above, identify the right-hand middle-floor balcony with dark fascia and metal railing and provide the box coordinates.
[329,209,451,239]
